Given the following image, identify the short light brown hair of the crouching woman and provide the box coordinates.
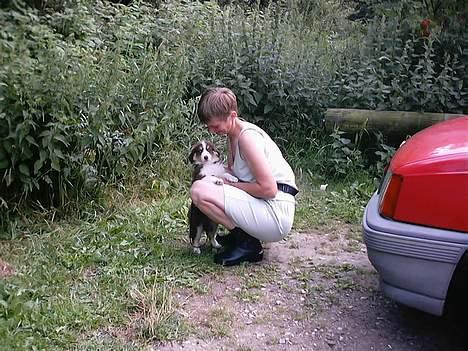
[197,87,237,123]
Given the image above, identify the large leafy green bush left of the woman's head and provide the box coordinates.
[0,2,189,212]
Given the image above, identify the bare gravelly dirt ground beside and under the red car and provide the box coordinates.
[154,224,468,351]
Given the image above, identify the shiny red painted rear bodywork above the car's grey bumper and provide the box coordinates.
[389,116,468,233]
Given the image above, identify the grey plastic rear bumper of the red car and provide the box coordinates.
[363,194,468,316]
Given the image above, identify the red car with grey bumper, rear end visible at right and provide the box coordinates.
[363,116,468,315]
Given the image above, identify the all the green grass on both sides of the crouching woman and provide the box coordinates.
[0,172,371,350]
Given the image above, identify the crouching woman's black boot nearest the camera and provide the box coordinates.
[214,228,263,266]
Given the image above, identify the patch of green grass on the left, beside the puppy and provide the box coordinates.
[0,196,219,349]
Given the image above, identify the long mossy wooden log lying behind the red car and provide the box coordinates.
[325,108,463,137]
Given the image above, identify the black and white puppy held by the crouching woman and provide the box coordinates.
[188,140,238,254]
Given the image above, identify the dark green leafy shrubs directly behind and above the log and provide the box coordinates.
[329,1,468,113]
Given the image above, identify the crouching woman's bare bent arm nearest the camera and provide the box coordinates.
[231,132,278,199]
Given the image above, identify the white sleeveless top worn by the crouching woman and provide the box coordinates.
[232,121,297,189]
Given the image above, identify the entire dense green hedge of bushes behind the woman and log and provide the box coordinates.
[0,0,467,217]
